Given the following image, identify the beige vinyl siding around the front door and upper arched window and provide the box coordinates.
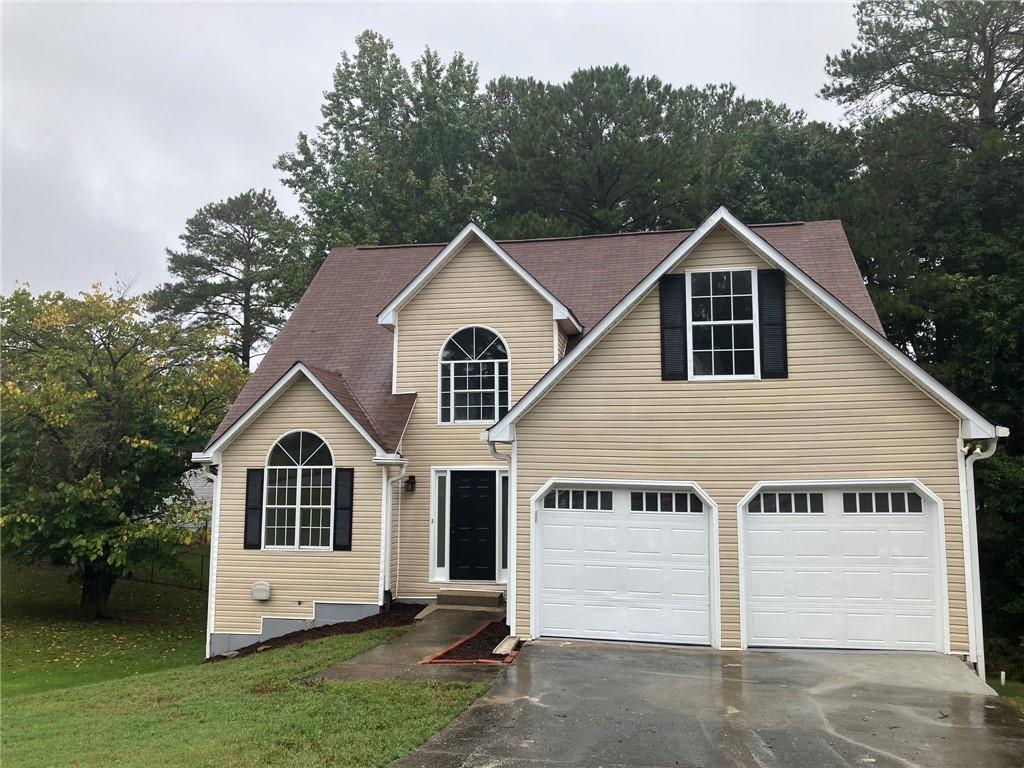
[391,240,555,598]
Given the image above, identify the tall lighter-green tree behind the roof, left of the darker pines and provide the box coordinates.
[275,31,490,258]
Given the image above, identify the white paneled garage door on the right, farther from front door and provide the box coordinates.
[743,488,943,650]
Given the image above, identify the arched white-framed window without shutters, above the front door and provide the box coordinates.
[439,327,509,424]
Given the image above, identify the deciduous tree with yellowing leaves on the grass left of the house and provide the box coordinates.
[0,287,247,617]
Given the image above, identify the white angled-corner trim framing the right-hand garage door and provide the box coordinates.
[736,477,952,653]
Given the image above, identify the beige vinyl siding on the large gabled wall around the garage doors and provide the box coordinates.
[516,231,968,651]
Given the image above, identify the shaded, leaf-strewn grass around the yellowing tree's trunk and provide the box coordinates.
[0,559,206,699]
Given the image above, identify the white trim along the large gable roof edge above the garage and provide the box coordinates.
[487,206,1005,442]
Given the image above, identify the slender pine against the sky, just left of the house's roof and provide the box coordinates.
[148,189,313,369]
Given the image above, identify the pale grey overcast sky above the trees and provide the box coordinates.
[0,2,855,292]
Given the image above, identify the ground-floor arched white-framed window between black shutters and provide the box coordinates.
[263,432,334,549]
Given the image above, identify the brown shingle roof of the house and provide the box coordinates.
[205,220,884,451]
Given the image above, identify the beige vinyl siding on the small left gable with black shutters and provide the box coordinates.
[213,379,382,632]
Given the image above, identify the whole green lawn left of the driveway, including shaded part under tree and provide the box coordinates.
[0,561,486,768]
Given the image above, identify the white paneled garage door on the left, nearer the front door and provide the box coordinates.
[537,487,711,644]
